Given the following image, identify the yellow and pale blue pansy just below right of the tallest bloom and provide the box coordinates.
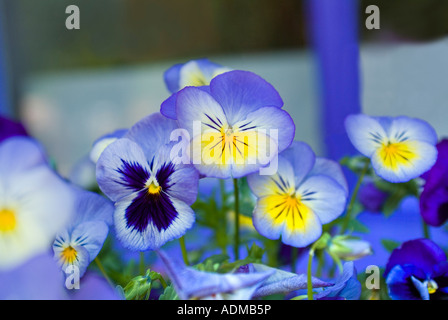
[247,142,348,247]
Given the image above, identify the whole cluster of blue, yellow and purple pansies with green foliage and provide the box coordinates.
[0,59,448,300]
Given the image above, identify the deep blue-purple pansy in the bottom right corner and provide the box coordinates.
[384,239,448,300]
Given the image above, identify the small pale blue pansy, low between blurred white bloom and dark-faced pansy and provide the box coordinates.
[53,189,114,277]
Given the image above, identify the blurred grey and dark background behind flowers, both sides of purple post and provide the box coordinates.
[0,0,448,175]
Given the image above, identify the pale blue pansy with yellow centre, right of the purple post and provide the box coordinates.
[345,114,437,183]
